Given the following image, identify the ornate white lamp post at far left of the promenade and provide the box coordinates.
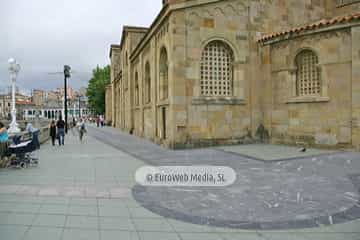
[8,58,20,133]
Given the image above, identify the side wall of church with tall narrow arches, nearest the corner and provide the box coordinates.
[125,22,172,144]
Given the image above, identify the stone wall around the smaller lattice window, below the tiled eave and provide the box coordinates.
[265,29,352,146]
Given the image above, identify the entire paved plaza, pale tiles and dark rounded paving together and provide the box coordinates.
[0,127,360,240]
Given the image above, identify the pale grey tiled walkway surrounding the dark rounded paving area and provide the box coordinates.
[0,128,360,240]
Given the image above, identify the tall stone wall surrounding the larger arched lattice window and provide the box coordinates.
[171,1,251,146]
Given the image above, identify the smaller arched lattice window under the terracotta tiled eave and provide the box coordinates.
[295,50,321,96]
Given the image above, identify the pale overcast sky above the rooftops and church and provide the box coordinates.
[0,0,162,92]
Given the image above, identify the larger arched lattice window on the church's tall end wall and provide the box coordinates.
[200,41,234,97]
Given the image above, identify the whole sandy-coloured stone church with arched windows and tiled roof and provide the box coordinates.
[106,0,360,148]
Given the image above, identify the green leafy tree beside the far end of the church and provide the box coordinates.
[86,65,110,114]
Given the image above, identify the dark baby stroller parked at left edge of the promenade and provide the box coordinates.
[9,131,40,168]
